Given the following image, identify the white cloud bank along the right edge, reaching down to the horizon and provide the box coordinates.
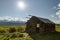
[50,3,60,24]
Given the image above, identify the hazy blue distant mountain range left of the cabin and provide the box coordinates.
[0,20,25,25]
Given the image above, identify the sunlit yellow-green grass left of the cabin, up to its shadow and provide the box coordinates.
[0,25,32,40]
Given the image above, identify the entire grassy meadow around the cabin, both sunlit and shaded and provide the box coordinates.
[0,25,60,40]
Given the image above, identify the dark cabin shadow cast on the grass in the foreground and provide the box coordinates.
[29,32,60,40]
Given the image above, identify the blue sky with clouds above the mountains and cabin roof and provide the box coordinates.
[0,0,60,23]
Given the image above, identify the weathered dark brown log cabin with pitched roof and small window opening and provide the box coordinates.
[26,16,55,34]
